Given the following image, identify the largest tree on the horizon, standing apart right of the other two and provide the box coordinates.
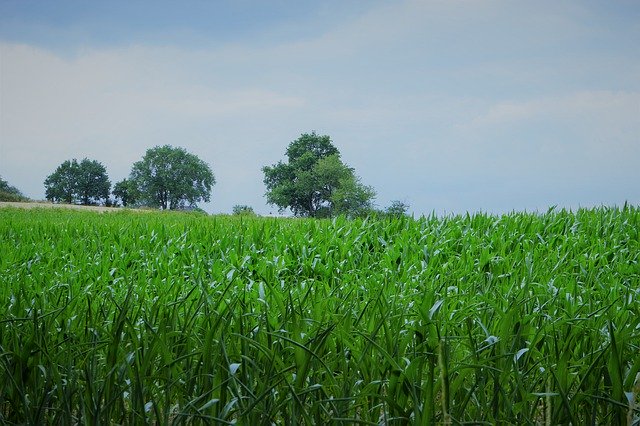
[262,132,375,217]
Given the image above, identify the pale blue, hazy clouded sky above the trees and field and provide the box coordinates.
[0,0,640,215]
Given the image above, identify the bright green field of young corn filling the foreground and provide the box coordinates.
[0,206,640,425]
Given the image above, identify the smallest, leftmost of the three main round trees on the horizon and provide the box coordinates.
[44,158,111,205]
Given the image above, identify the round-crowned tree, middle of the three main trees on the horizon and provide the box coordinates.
[129,145,216,210]
